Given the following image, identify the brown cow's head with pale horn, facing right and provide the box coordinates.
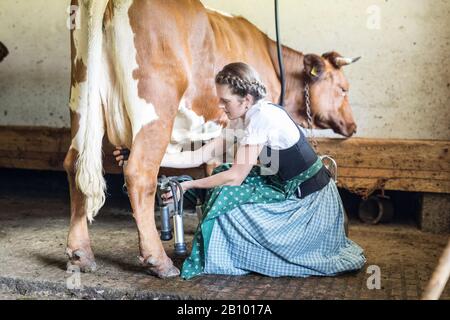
[304,52,360,137]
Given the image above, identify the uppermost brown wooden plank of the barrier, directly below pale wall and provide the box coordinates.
[0,127,450,172]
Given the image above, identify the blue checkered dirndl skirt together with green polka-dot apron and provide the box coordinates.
[181,159,366,280]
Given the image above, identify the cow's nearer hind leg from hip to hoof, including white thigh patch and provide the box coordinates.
[107,1,190,278]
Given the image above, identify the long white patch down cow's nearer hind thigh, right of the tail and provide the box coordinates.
[111,0,159,140]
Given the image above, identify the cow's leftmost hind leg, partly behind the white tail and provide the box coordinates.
[64,112,97,272]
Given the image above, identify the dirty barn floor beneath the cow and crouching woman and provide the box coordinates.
[0,170,450,300]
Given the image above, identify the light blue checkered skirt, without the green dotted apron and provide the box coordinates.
[204,181,366,277]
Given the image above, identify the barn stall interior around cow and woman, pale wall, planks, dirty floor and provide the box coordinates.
[0,0,450,299]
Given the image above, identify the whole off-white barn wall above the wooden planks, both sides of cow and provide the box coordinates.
[0,0,450,140]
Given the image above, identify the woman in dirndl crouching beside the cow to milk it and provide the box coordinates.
[115,63,366,279]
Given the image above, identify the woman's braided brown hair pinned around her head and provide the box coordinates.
[216,62,267,102]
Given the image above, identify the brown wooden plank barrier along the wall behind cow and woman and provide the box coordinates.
[0,127,450,193]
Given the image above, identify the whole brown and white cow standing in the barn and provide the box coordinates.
[64,0,356,278]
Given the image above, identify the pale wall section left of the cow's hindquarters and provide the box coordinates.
[0,0,70,127]
